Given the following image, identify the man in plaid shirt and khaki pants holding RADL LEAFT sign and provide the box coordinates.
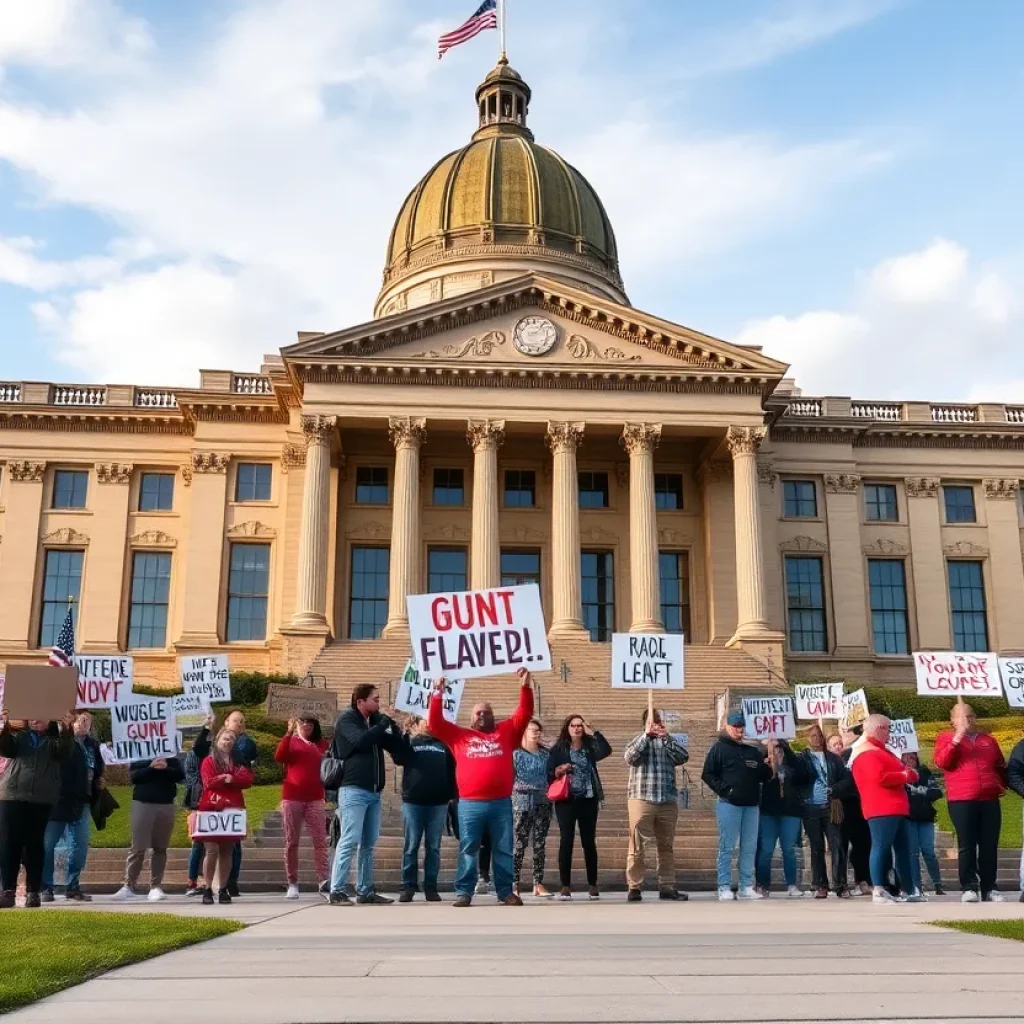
[625,711,689,903]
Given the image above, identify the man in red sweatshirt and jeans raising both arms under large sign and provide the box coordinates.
[427,669,534,907]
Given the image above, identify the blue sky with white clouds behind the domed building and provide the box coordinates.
[0,0,1024,403]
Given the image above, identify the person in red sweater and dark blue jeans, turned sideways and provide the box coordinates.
[850,715,925,903]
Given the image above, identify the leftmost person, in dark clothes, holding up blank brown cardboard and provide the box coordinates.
[0,711,75,909]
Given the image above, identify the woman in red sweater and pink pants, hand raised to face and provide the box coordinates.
[273,718,330,899]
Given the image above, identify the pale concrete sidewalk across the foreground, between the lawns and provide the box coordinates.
[9,894,1024,1024]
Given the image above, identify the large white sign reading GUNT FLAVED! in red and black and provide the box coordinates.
[408,584,551,679]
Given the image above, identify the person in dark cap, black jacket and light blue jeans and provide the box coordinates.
[700,712,771,900]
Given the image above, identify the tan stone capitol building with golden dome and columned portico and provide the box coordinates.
[0,61,1024,687]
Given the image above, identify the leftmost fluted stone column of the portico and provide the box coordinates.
[292,416,338,633]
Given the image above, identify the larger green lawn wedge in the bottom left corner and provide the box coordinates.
[0,910,244,1016]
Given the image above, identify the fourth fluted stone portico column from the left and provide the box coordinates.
[547,423,585,636]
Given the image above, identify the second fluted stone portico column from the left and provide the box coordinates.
[383,416,427,637]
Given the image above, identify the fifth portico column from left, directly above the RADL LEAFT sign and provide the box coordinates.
[622,423,665,633]
